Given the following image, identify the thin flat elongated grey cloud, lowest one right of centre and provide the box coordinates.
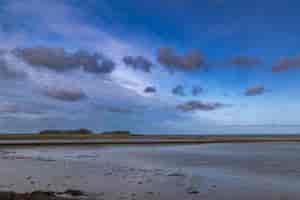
[176,101,224,112]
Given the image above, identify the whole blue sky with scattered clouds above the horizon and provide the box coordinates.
[0,0,300,134]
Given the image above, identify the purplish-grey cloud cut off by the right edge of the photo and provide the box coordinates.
[272,55,300,73]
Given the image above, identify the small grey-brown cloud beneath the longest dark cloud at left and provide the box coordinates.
[43,87,87,102]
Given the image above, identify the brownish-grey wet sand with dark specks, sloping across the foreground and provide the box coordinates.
[0,145,300,200]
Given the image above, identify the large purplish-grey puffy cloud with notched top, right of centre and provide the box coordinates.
[157,47,204,70]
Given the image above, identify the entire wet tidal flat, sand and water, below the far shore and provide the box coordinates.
[0,142,300,200]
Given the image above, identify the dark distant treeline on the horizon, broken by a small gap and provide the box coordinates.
[39,129,131,135]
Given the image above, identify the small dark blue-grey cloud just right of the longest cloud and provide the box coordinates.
[123,56,153,72]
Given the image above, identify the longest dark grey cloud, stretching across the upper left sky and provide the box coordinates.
[12,46,115,73]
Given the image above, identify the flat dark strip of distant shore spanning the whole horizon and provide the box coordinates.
[0,133,300,145]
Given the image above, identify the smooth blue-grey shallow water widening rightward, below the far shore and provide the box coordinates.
[2,142,300,198]
